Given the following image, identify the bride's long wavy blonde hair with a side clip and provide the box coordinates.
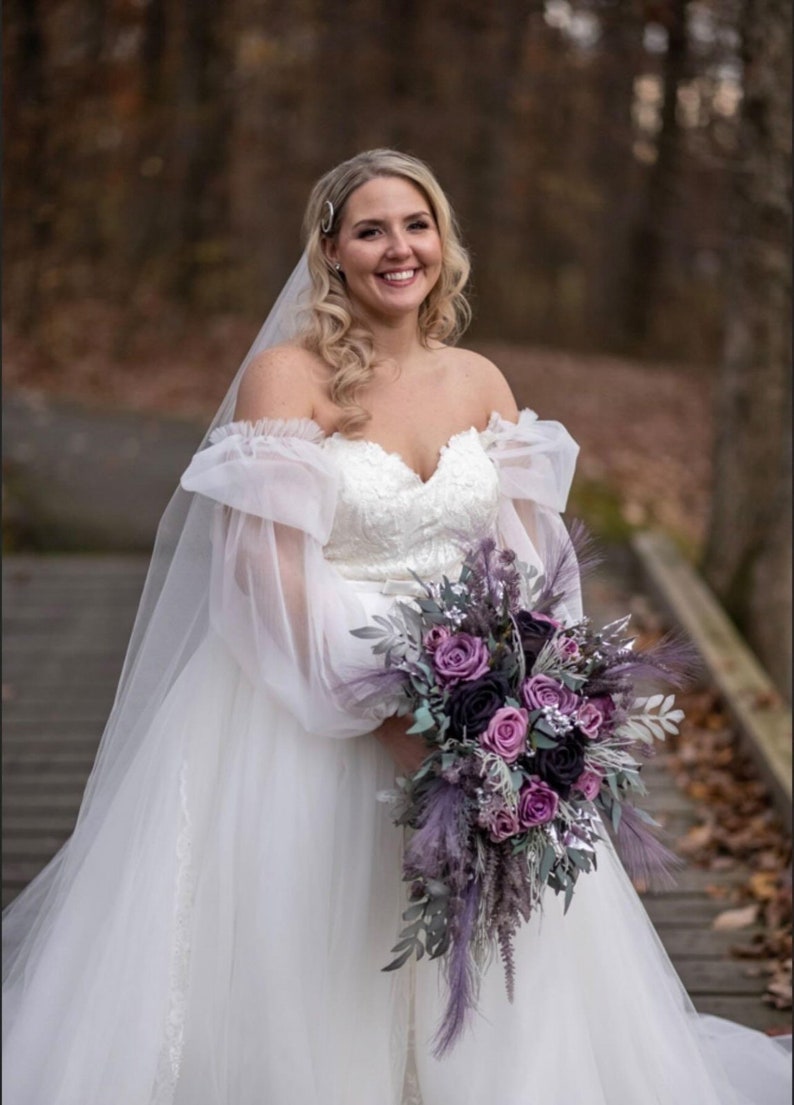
[301,149,472,435]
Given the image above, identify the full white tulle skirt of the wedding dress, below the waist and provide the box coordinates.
[3,623,791,1105]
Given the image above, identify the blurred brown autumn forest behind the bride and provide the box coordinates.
[3,0,791,693]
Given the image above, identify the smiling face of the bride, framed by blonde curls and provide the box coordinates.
[326,177,442,320]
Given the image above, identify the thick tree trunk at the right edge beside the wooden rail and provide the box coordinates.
[703,0,792,695]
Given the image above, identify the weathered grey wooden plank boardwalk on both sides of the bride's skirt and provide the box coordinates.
[2,555,786,1029]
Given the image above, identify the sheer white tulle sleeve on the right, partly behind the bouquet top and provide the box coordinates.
[486,410,582,622]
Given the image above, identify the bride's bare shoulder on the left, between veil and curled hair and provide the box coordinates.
[234,343,326,422]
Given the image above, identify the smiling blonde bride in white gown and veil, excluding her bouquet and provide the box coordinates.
[3,150,790,1105]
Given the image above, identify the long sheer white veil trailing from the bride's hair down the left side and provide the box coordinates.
[3,253,310,976]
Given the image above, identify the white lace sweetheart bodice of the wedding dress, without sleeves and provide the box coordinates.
[324,428,499,580]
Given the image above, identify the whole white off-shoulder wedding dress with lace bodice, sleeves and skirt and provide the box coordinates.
[3,411,790,1105]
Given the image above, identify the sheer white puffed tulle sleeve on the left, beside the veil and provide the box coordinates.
[181,419,392,737]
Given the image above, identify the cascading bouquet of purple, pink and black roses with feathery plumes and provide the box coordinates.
[353,541,684,1055]
